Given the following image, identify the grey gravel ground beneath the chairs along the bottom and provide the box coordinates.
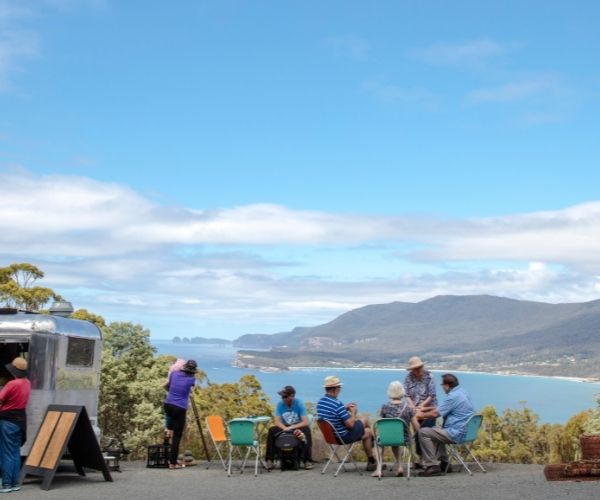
[16,462,600,500]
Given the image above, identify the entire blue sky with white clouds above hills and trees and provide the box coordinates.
[0,0,600,338]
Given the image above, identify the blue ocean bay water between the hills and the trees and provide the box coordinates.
[152,340,600,424]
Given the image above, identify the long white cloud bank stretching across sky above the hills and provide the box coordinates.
[0,170,600,336]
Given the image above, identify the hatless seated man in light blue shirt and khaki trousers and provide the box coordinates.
[417,373,475,476]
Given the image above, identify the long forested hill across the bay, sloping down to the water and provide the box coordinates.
[234,295,600,377]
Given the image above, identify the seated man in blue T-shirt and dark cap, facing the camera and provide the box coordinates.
[265,385,313,470]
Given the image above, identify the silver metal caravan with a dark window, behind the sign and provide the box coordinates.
[0,310,102,455]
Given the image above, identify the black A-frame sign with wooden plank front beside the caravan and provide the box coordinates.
[21,405,112,490]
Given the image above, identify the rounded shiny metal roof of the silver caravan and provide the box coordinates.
[0,313,102,339]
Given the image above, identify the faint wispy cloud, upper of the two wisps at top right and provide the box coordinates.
[407,38,510,66]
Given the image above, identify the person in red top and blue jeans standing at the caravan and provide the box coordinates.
[0,358,31,493]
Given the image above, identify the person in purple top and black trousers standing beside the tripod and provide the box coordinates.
[164,359,198,469]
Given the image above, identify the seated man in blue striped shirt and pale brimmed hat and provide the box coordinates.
[317,376,376,471]
